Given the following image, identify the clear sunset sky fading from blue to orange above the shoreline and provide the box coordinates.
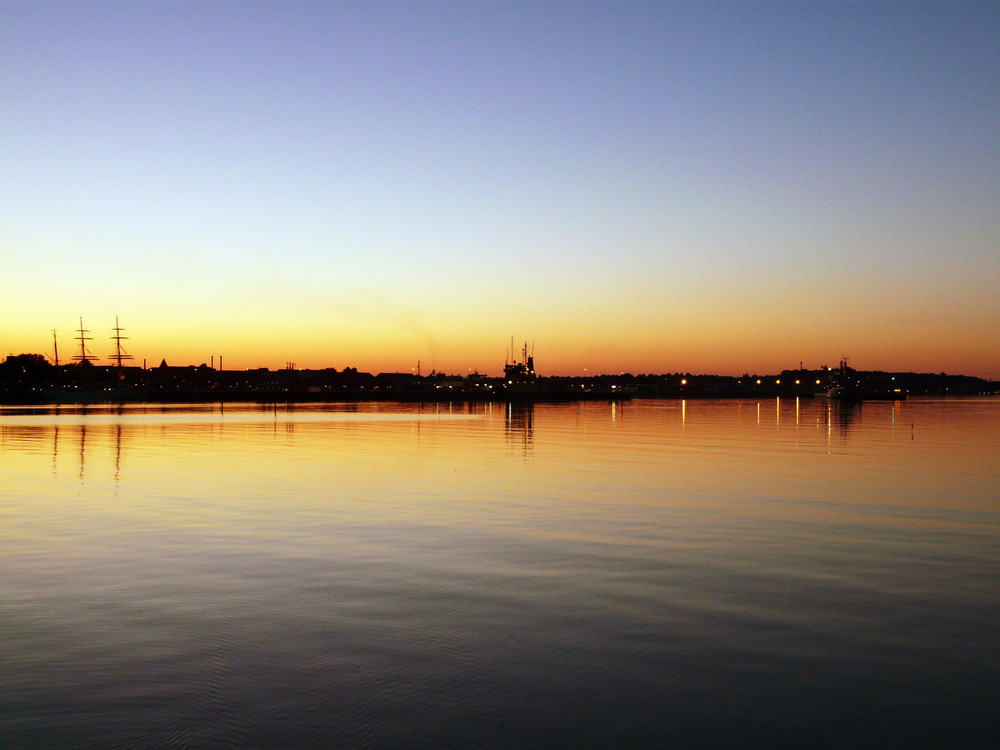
[0,2,1000,379]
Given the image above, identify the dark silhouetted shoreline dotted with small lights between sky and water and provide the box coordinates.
[0,354,1000,405]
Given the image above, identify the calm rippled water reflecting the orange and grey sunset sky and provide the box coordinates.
[0,399,1000,748]
